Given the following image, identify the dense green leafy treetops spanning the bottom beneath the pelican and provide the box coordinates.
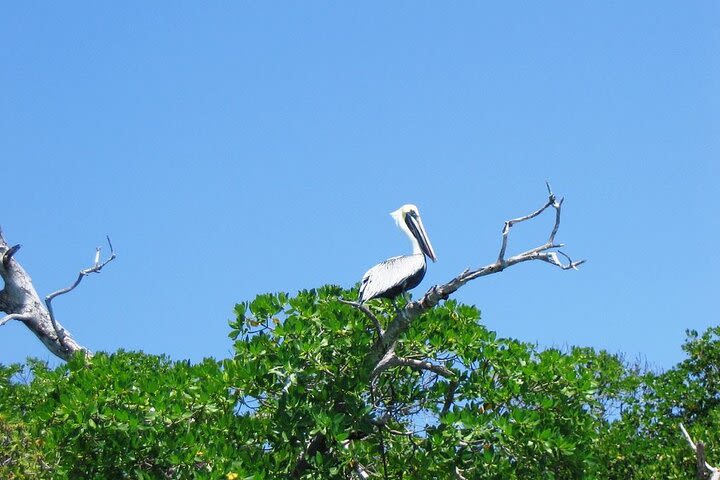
[0,287,720,480]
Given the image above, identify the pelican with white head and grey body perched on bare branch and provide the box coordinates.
[359,204,437,303]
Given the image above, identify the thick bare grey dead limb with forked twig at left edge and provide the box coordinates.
[0,231,116,361]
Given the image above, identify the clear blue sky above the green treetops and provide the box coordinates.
[0,1,720,368]
